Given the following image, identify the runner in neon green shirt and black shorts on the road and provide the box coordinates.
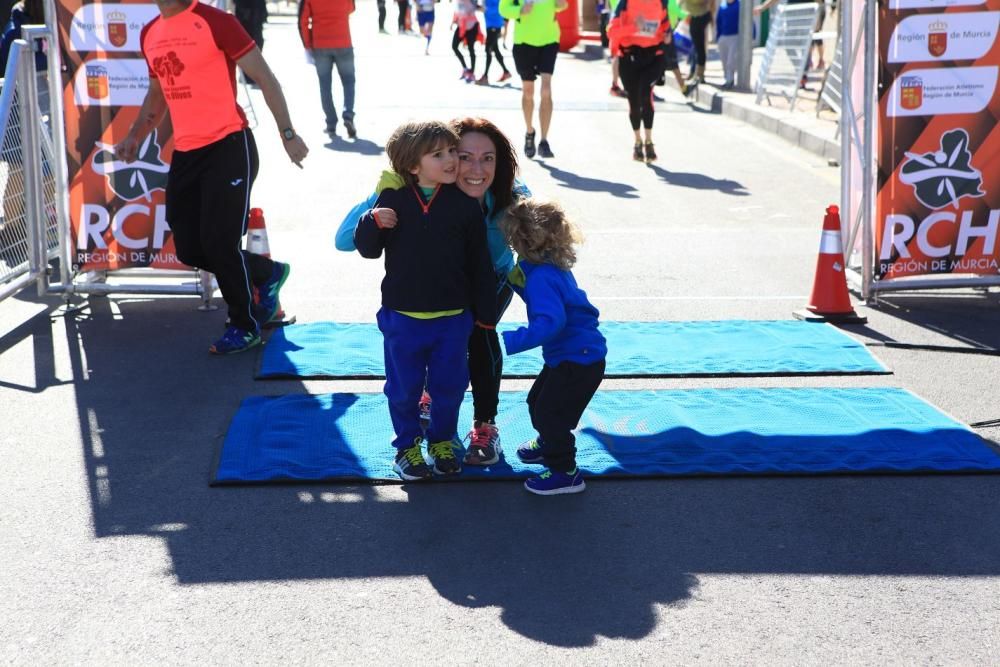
[500,0,568,158]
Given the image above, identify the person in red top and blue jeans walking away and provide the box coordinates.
[299,0,358,139]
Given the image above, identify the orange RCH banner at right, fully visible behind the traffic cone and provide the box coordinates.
[875,0,1000,279]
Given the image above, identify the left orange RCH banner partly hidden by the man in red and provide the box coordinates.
[57,0,188,271]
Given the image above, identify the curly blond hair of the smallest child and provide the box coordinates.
[500,198,583,270]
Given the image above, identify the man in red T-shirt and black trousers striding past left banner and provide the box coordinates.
[115,0,309,354]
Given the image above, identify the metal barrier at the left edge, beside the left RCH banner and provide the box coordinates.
[0,36,60,300]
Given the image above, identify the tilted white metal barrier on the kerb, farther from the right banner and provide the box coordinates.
[756,2,820,110]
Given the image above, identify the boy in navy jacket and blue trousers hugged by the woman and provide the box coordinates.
[354,121,497,481]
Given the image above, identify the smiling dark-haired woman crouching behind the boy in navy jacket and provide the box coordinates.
[336,118,531,466]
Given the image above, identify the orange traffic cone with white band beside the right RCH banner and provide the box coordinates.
[794,206,868,324]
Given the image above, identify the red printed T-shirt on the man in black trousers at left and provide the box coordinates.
[141,0,256,151]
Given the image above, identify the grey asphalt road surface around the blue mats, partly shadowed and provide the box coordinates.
[0,2,1000,665]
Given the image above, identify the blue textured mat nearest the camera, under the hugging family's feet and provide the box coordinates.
[207,388,1000,484]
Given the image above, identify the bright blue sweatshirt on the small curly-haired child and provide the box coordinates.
[502,260,608,366]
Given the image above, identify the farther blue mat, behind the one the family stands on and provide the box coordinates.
[256,320,889,379]
